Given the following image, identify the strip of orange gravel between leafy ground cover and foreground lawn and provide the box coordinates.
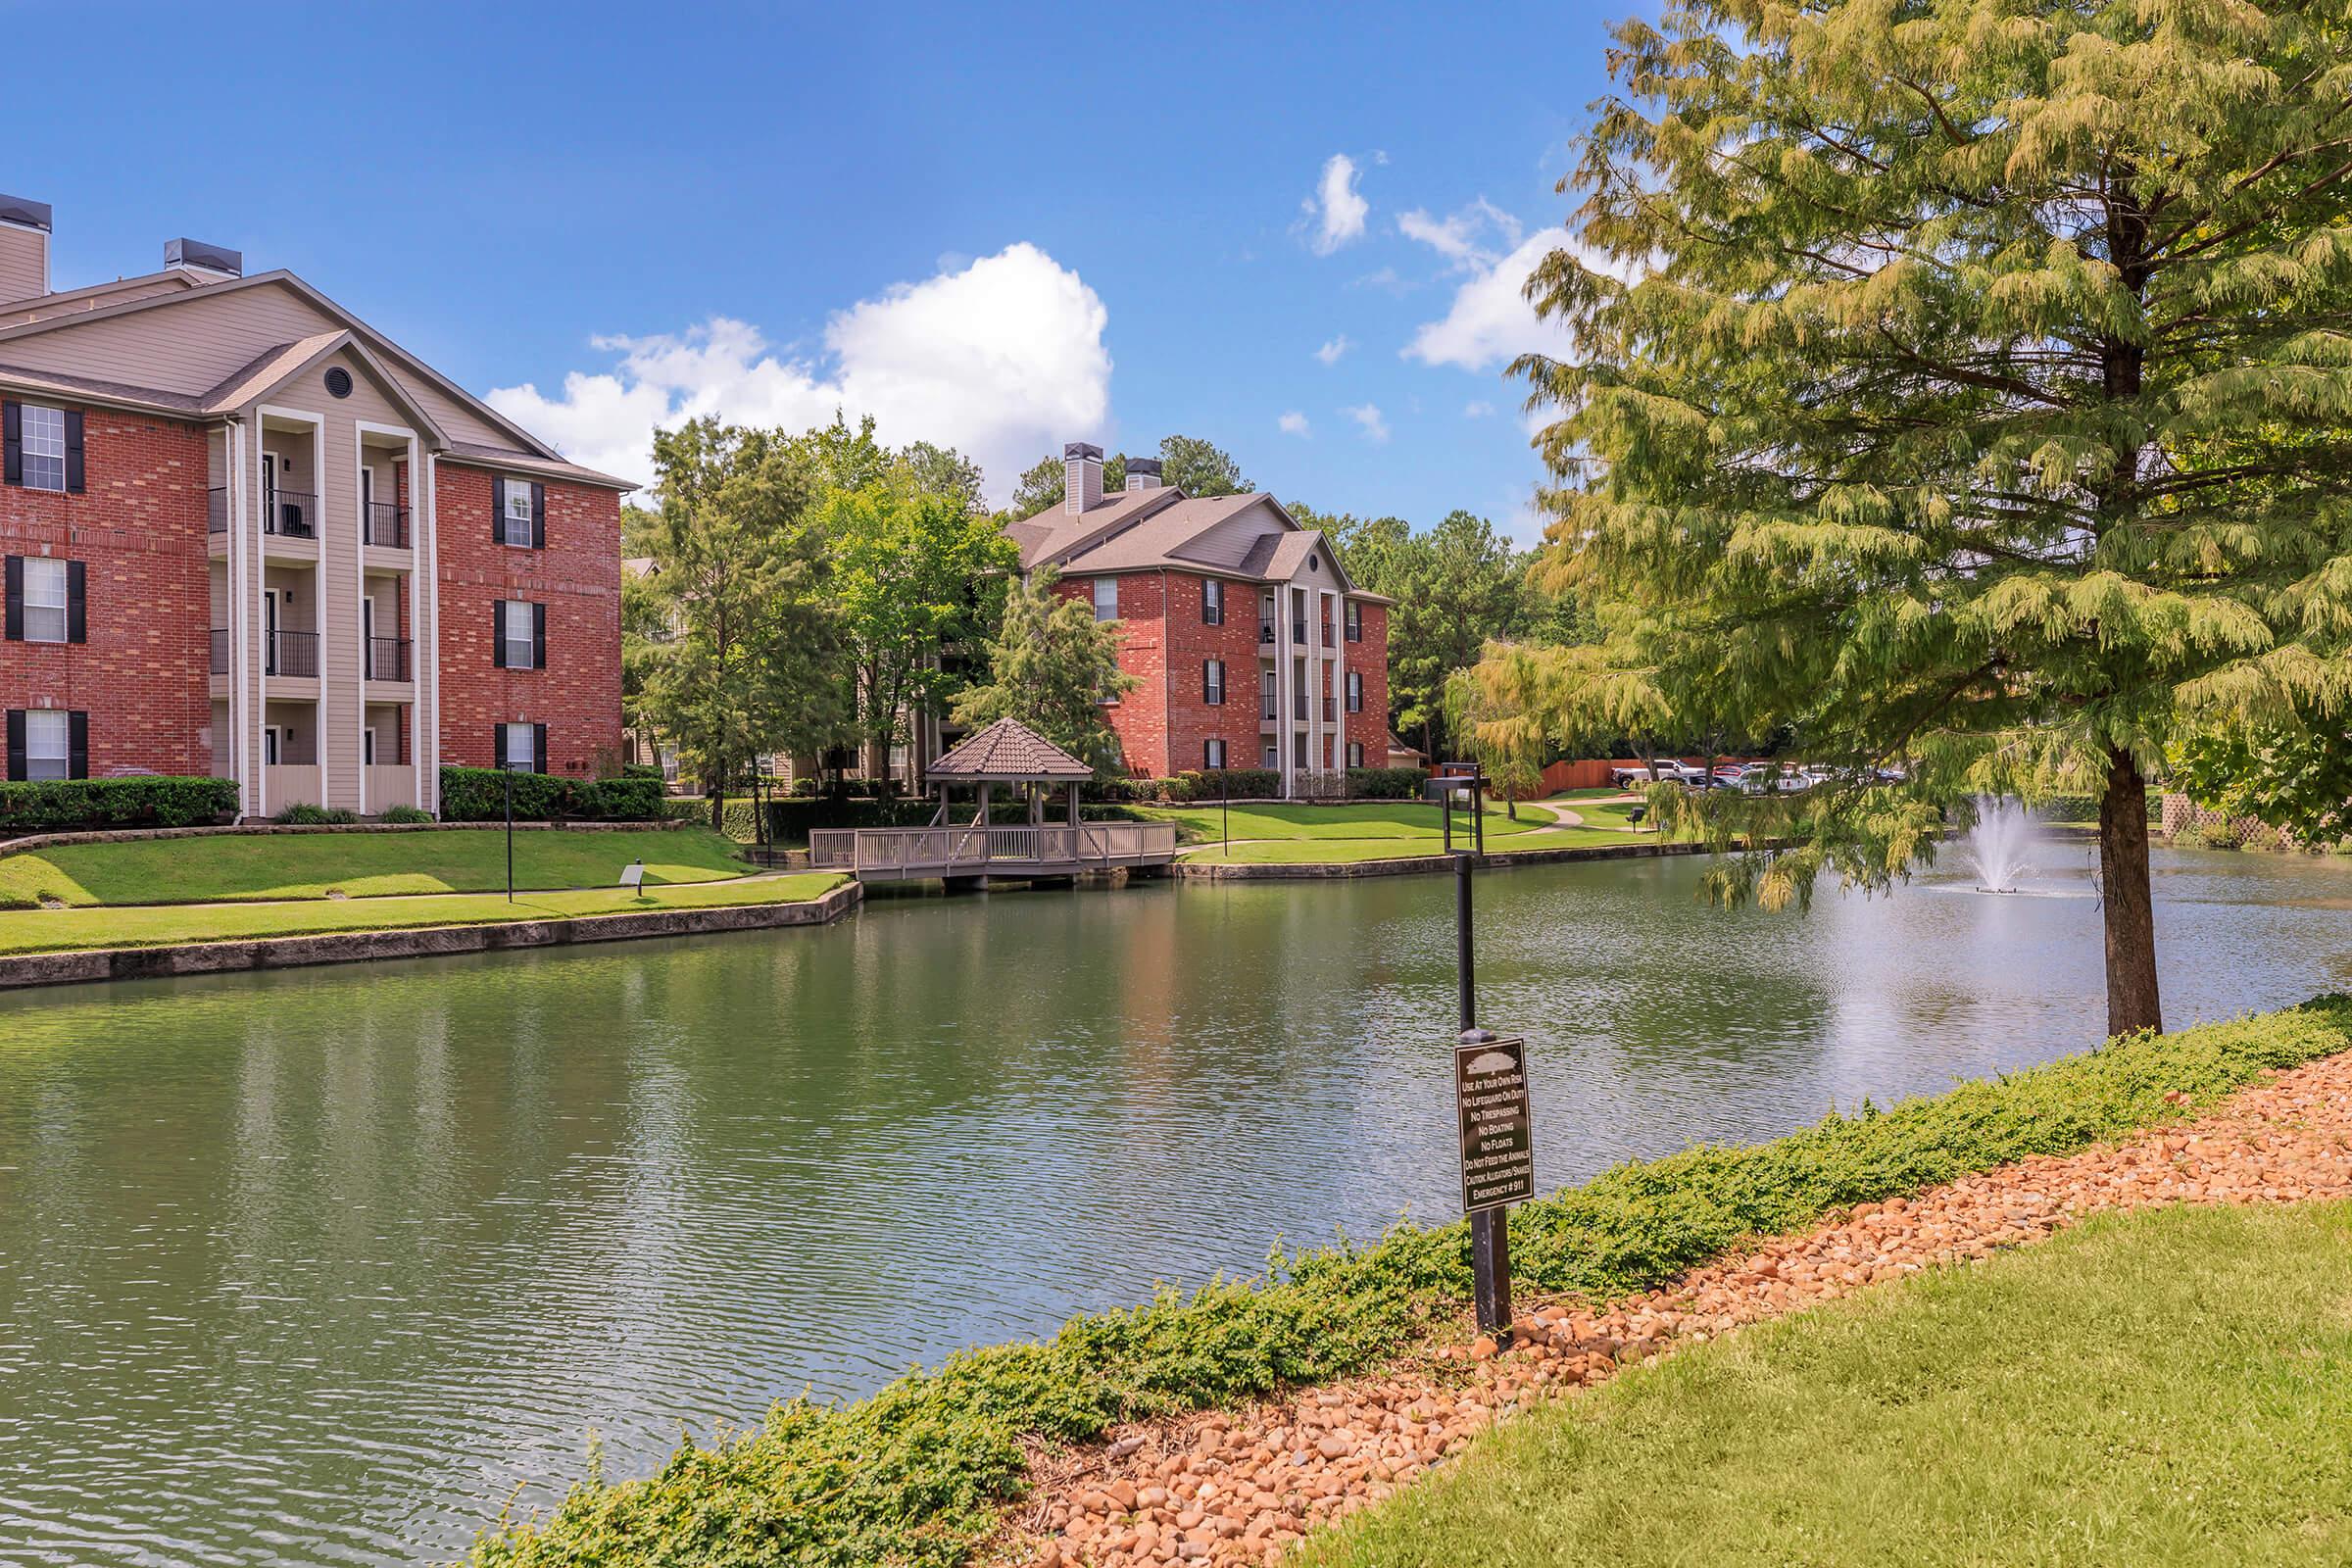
[993,1054,2352,1568]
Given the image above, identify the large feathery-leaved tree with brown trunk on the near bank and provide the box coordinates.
[1515,0,2352,1032]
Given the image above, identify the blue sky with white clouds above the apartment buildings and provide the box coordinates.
[14,0,1635,538]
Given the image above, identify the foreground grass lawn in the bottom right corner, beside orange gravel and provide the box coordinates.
[1287,1203,2352,1568]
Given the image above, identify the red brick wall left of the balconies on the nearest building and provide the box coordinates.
[0,402,212,778]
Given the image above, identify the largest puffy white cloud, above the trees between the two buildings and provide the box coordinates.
[489,242,1110,503]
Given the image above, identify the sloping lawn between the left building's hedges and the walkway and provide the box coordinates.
[0,827,748,909]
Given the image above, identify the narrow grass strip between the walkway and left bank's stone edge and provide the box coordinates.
[0,872,845,955]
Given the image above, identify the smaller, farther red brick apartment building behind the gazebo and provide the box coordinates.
[1011,442,1395,795]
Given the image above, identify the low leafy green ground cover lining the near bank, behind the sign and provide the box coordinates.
[470,997,2352,1568]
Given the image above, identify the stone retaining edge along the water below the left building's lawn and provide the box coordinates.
[0,882,863,990]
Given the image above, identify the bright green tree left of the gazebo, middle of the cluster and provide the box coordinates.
[823,484,1021,778]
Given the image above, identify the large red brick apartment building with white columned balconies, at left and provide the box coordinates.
[0,197,630,815]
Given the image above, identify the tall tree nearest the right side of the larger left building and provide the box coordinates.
[635,418,845,827]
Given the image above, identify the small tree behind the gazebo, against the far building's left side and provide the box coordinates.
[955,566,1136,778]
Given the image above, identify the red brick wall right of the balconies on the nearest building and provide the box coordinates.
[435,461,621,778]
